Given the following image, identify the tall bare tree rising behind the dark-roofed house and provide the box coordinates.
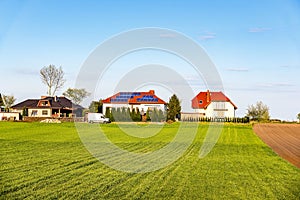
[40,65,66,96]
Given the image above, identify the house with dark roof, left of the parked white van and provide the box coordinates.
[11,96,83,117]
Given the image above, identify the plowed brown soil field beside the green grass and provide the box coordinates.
[253,124,300,168]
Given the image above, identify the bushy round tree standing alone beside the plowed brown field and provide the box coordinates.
[246,101,270,121]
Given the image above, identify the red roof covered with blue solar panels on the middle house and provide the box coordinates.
[102,90,166,104]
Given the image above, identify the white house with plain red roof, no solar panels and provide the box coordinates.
[192,90,237,118]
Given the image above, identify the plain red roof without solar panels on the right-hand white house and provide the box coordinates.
[192,90,237,109]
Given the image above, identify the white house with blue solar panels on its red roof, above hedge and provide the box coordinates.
[102,90,166,112]
